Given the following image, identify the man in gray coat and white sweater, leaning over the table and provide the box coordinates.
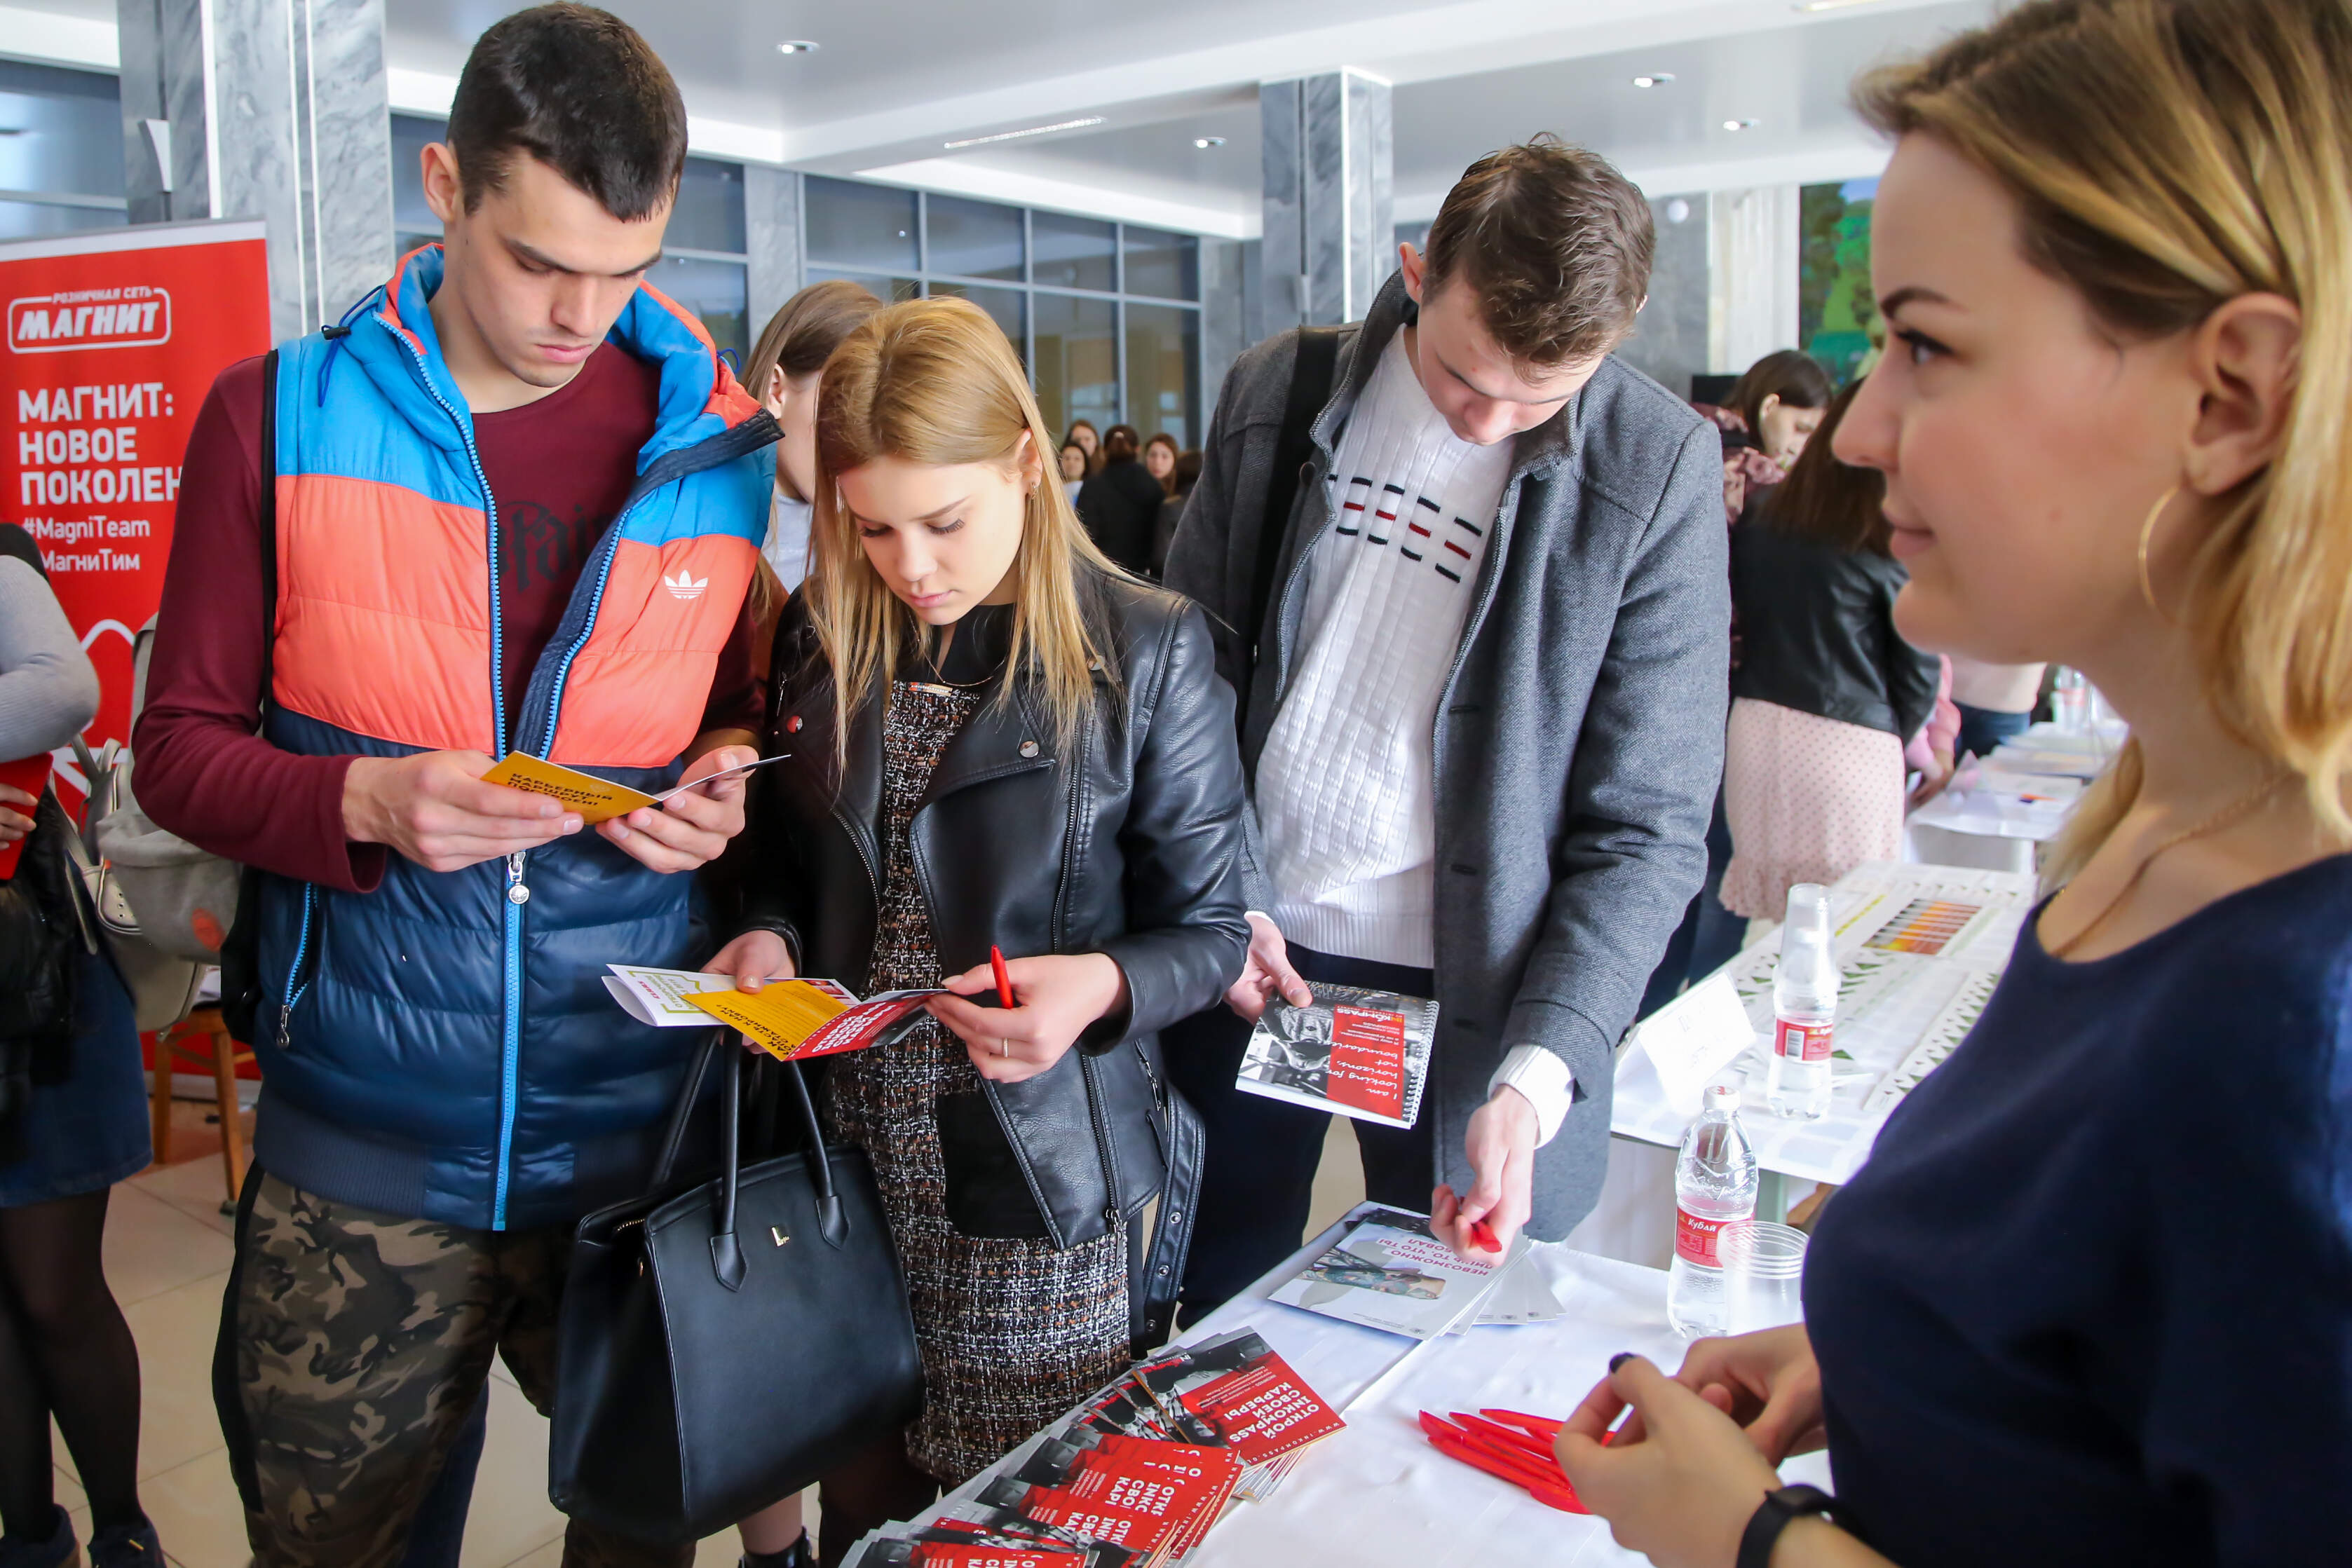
[1164,139,1731,1316]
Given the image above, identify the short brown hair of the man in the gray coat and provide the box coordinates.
[1420,134,1658,367]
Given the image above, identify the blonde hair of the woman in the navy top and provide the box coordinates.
[1856,0,2352,884]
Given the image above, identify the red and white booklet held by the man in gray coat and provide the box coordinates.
[1232,985,1437,1126]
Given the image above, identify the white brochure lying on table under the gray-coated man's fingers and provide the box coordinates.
[1272,1208,1529,1340]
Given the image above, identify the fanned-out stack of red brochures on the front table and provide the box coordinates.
[849,1328,1345,1568]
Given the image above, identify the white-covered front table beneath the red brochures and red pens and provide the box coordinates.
[903,1220,1828,1568]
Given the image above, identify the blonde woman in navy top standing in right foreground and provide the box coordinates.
[1559,0,2352,1568]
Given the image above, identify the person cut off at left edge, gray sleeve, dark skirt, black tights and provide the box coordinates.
[0,524,162,1568]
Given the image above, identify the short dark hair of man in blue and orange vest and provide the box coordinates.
[449,2,687,224]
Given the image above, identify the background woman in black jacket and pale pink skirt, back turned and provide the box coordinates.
[1720,388,1943,919]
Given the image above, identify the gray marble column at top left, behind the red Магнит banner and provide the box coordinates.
[115,0,393,339]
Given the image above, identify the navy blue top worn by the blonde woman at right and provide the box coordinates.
[1804,856,2352,1568]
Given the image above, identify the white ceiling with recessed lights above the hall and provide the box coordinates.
[0,0,1997,235]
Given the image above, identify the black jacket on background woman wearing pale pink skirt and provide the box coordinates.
[1731,503,1943,740]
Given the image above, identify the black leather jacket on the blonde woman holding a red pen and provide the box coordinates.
[746,580,1249,1335]
